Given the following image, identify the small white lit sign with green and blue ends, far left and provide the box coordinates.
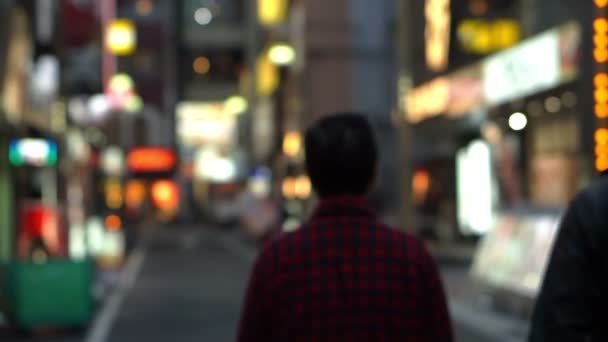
[9,138,57,167]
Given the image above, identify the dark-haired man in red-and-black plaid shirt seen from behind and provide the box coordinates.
[238,114,453,342]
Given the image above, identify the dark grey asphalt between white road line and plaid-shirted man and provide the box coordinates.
[100,227,253,342]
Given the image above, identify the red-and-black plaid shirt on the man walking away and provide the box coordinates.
[239,197,452,341]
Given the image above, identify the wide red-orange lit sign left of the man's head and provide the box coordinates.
[127,147,177,173]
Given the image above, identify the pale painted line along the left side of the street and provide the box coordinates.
[85,248,146,342]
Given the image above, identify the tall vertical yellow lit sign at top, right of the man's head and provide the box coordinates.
[424,0,452,71]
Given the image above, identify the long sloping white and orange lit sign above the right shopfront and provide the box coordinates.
[403,22,581,123]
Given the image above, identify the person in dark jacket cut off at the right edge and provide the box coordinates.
[529,178,608,342]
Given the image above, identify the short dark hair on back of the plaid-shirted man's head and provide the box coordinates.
[305,113,378,197]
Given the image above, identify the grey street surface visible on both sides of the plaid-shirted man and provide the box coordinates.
[87,226,524,342]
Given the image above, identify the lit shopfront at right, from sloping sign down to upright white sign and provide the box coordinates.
[404,22,589,236]
